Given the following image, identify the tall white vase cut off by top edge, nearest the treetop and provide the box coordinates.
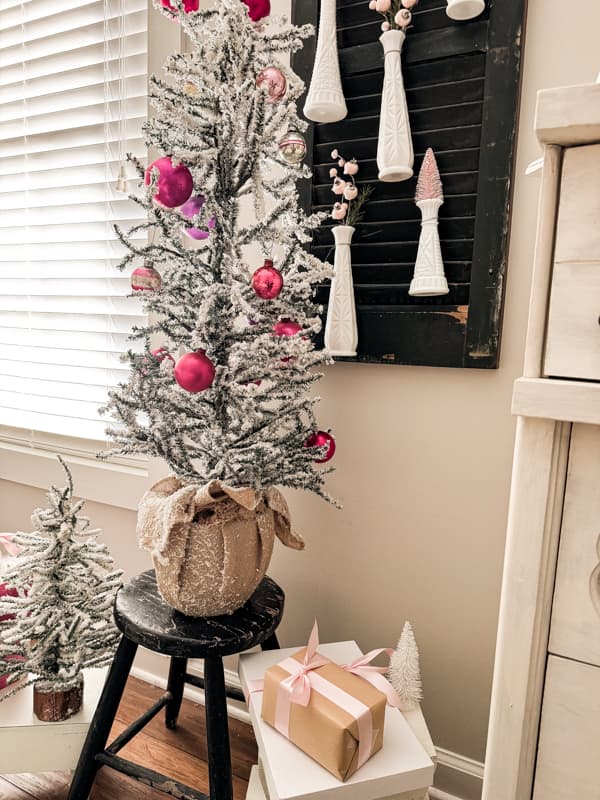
[304,0,348,122]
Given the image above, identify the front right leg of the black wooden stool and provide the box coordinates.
[204,656,233,800]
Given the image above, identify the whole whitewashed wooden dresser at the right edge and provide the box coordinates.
[483,84,600,800]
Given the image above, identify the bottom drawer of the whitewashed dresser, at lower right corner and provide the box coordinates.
[533,656,600,800]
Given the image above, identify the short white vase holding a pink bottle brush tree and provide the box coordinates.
[408,198,448,297]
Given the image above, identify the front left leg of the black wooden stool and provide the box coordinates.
[68,636,137,800]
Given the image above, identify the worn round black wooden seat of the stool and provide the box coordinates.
[115,570,284,658]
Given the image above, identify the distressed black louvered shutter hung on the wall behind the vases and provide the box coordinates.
[292,0,525,368]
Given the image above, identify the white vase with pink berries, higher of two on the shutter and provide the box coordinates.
[377,30,415,181]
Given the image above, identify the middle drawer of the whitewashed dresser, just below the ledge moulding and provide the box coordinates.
[548,425,600,664]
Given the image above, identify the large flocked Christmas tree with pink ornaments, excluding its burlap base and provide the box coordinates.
[108,0,335,497]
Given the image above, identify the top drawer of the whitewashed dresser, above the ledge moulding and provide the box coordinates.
[544,145,600,380]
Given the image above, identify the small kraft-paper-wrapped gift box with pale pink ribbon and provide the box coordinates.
[262,625,387,781]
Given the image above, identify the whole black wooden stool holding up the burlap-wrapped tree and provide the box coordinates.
[68,570,284,800]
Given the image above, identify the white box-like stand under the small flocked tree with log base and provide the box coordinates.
[0,668,107,775]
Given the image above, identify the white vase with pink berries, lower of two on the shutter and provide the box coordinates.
[325,225,358,356]
